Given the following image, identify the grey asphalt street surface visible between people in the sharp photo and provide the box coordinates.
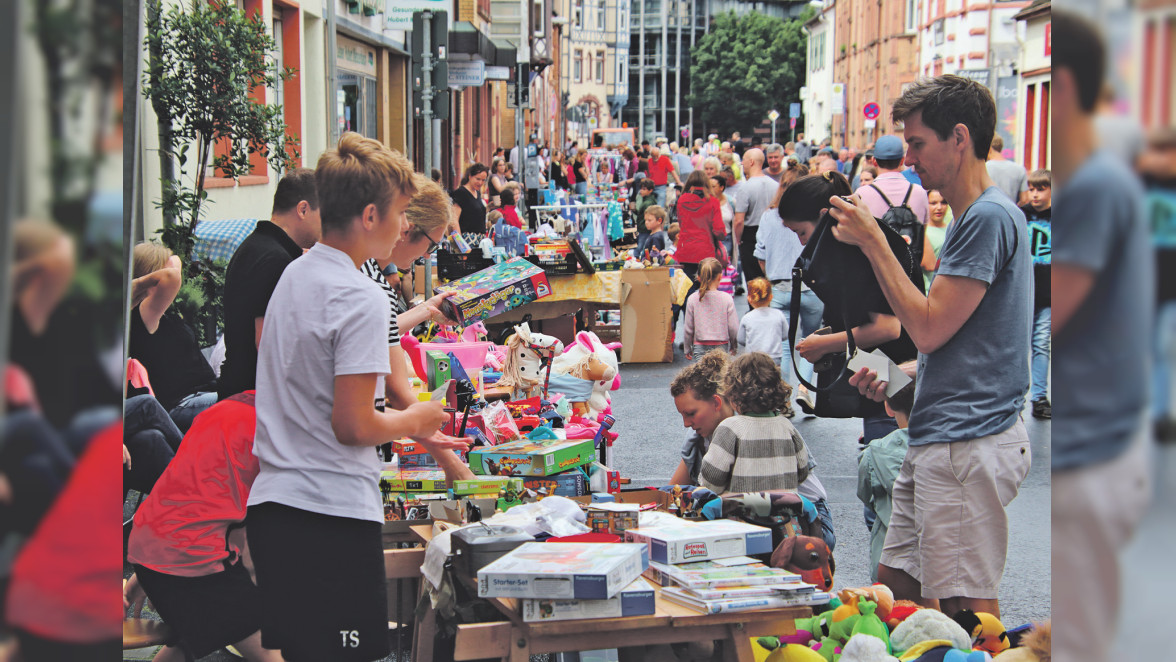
[609,296,1050,627]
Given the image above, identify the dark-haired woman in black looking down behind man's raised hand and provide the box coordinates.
[779,172,922,443]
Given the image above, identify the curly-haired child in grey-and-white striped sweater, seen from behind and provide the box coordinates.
[699,352,809,494]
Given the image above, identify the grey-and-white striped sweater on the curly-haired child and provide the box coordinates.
[699,414,809,494]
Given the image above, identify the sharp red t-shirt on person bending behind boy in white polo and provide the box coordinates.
[127,390,259,577]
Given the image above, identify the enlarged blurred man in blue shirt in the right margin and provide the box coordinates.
[1050,9,1155,662]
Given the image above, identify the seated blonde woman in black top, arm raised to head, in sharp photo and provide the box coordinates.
[131,242,216,433]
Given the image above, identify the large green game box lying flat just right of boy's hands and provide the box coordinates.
[469,439,596,476]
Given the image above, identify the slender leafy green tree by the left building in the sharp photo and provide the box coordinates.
[142,0,299,342]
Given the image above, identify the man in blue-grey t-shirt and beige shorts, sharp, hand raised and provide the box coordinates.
[830,75,1033,615]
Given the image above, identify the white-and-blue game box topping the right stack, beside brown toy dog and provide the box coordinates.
[624,520,771,563]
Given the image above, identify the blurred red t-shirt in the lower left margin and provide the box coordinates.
[6,421,122,644]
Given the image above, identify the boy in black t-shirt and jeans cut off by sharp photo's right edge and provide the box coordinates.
[1021,170,1054,419]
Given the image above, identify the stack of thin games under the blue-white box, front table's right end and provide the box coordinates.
[646,556,829,614]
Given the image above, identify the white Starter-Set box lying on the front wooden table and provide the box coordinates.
[477,542,649,600]
